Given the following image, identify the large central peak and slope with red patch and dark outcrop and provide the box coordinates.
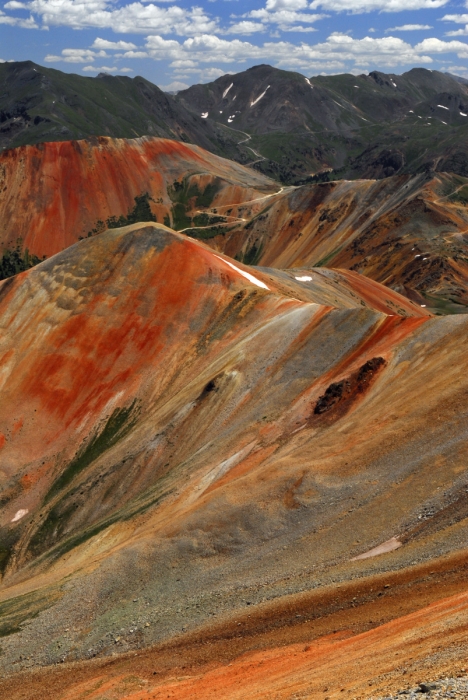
[0,224,468,688]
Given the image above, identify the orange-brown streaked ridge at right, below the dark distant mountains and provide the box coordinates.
[206,173,468,311]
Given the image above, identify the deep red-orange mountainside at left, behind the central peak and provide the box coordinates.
[0,137,279,258]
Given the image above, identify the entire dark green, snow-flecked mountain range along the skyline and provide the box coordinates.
[0,61,468,184]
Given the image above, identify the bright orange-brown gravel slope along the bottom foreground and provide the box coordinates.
[0,553,468,700]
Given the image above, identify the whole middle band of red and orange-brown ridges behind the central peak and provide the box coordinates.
[0,137,468,313]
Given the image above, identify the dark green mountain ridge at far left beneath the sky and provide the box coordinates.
[0,61,232,157]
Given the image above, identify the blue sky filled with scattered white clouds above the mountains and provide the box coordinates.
[0,0,468,90]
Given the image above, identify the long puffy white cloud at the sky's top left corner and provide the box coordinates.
[0,0,218,36]
